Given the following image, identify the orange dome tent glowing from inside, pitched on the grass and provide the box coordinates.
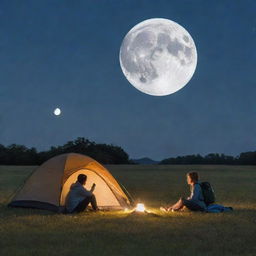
[9,153,131,212]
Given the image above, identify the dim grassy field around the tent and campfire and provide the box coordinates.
[0,166,256,256]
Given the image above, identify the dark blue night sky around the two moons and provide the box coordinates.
[0,0,256,159]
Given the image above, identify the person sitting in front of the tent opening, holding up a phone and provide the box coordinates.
[66,174,99,213]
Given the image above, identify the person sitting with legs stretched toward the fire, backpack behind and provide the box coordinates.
[160,172,207,212]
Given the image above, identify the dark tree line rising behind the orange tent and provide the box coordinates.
[0,138,131,165]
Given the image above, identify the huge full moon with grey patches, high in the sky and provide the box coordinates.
[119,18,197,96]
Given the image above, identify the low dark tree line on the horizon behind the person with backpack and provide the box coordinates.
[159,151,256,165]
